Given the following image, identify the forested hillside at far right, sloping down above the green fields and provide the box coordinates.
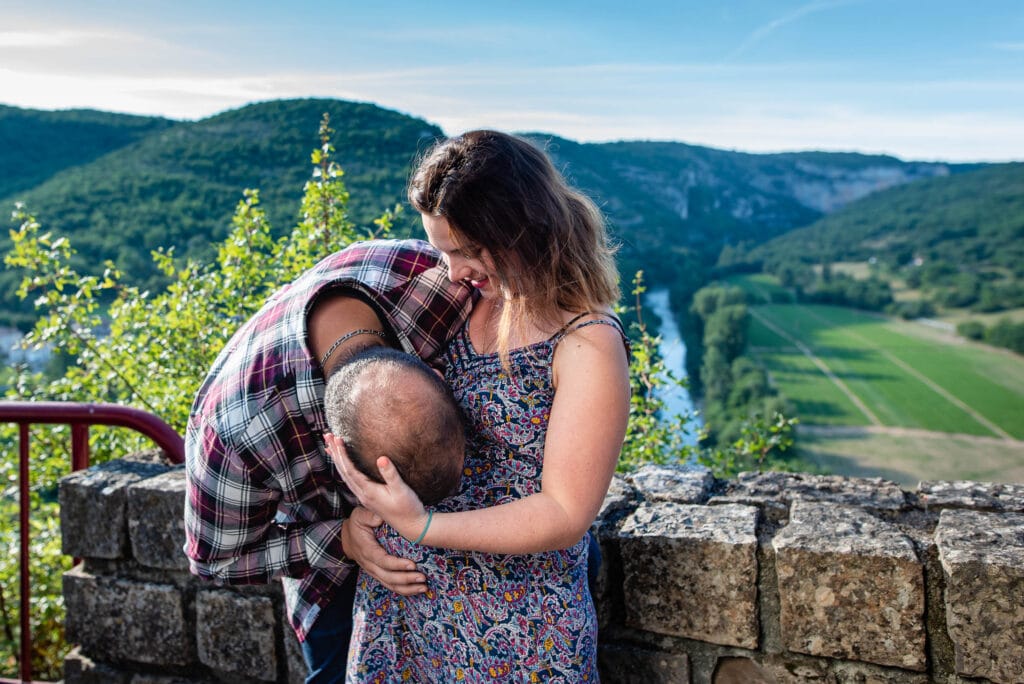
[751,164,1024,310]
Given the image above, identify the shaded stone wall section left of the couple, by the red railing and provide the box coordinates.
[59,454,305,684]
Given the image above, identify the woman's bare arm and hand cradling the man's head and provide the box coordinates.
[328,325,630,553]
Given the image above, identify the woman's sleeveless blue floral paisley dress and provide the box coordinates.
[347,318,625,684]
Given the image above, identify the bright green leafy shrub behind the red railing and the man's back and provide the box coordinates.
[0,117,368,679]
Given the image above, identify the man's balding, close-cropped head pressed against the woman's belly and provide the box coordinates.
[324,347,466,504]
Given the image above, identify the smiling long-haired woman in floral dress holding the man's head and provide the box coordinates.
[328,131,629,682]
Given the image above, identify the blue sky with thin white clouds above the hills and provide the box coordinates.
[0,0,1024,161]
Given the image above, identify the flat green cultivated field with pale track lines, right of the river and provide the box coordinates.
[736,290,1024,484]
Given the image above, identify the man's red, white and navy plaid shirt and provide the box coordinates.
[184,240,471,640]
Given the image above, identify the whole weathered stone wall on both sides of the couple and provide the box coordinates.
[60,457,1024,684]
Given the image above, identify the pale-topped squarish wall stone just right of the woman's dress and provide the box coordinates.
[621,503,758,648]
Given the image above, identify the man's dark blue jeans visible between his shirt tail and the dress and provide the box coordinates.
[302,568,359,684]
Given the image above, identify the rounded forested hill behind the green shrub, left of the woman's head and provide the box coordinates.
[0,99,441,325]
